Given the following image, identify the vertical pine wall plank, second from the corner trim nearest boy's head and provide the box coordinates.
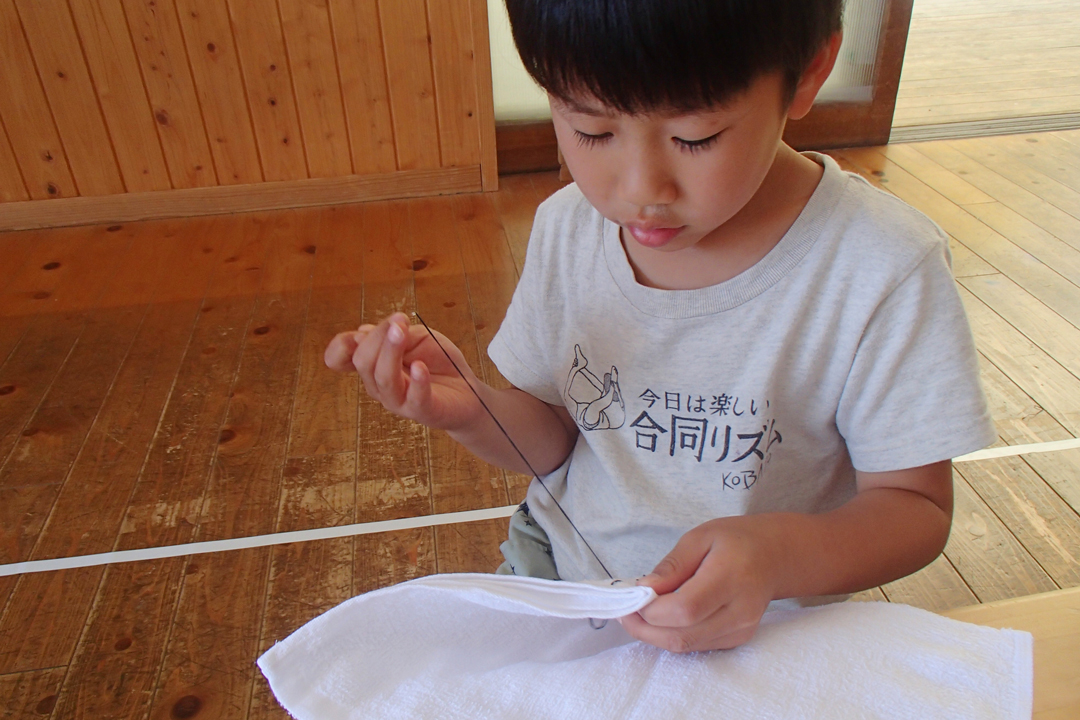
[379,0,440,169]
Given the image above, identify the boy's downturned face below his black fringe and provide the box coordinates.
[551,72,807,252]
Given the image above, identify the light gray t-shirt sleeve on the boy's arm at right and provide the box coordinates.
[836,242,997,473]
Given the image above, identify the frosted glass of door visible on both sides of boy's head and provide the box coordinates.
[487,0,887,122]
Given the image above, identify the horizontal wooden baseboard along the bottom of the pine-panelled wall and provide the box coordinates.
[0,165,482,231]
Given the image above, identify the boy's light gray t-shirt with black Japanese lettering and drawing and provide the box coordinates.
[488,154,996,580]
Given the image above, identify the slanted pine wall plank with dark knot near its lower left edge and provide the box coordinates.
[123,0,217,188]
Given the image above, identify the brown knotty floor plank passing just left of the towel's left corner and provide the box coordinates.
[144,210,315,718]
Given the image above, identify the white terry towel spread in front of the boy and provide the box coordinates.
[258,574,1031,720]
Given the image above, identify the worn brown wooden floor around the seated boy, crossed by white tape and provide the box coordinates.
[0,132,1080,720]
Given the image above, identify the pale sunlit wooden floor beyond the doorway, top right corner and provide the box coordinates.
[893,0,1080,127]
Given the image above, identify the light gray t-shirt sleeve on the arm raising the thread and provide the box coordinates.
[487,205,563,405]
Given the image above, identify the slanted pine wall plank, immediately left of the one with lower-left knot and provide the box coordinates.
[71,0,173,192]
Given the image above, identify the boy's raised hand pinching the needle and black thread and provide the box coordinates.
[324,313,483,431]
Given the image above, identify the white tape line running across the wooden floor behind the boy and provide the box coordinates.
[0,438,1080,578]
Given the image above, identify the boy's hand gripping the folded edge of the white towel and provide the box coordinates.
[619,515,779,653]
